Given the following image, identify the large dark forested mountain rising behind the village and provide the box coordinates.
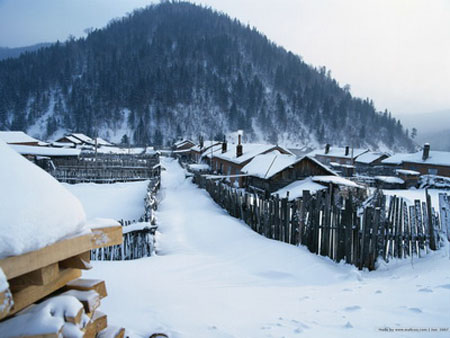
[0,2,412,149]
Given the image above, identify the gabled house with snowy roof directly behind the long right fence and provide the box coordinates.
[241,150,337,193]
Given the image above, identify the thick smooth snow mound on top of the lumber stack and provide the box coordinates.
[0,140,86,258]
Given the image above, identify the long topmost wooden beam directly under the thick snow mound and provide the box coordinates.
[0,226,123,280]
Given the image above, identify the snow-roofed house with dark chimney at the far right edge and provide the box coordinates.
[382,144,450,177]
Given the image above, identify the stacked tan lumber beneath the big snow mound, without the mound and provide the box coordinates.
[0,226,125,338]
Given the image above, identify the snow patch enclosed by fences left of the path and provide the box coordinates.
[64,181,148,221]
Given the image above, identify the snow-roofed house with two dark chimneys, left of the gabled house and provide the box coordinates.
[211,135,292,186]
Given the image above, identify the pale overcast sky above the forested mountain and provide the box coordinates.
[0,0,450,116]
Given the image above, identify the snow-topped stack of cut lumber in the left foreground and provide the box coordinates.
[0,141,124,337]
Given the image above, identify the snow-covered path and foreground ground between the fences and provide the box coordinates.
[85,159,450,338]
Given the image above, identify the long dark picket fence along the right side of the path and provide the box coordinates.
[194,174,450,270]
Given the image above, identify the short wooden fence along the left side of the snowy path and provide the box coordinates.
[91,177,161,260]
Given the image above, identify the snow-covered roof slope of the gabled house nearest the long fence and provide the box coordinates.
[241,150,298,178]
